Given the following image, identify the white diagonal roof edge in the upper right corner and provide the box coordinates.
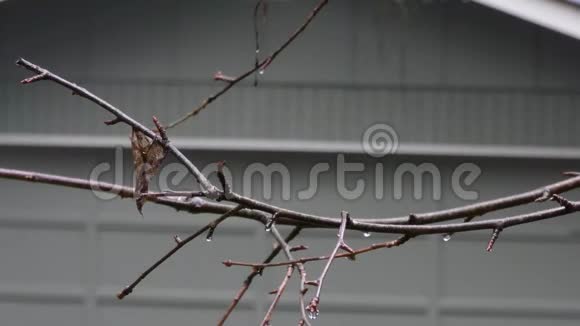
[473,0,580,39]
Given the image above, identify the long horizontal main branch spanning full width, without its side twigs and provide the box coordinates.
[0,168,580,235]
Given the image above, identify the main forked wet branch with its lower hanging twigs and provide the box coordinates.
[0,58,580,318]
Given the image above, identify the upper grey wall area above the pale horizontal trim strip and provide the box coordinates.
[0,0,580,146]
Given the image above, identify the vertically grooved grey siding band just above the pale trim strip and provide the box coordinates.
[0,79,580,147]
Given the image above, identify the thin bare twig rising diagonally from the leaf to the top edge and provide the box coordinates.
[167,0,328,128]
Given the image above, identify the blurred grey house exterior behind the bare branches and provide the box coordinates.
[0,0,580,326]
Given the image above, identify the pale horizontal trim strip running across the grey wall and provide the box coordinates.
[0,133,580,160]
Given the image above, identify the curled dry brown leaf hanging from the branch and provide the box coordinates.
[131,128,167,215]
